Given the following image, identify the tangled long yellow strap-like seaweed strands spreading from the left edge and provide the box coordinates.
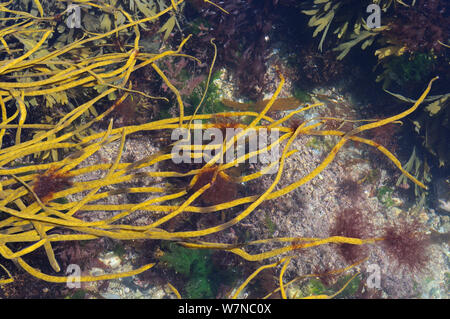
[0,0,436,298]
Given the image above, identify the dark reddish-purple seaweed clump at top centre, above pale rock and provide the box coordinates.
[186,0,295,100]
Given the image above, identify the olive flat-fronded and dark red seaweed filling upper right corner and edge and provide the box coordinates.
[299,0,450,176]
